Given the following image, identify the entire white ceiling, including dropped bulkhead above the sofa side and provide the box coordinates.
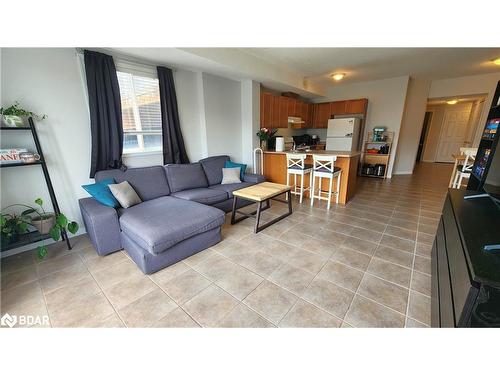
[110,48,500,97]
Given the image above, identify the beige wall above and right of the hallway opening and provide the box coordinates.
[429,73,500,144]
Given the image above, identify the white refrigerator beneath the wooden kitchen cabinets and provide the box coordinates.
[326,118,361,151]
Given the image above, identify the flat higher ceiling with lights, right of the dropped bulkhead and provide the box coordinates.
[243,48,500,84]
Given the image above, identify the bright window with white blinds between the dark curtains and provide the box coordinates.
[117,72,162,154]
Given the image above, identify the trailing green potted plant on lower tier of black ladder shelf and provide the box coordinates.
[1,198,78,259]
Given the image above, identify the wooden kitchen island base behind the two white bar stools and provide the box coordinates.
[264,150,361,204]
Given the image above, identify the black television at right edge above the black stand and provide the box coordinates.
[465,81,500,203]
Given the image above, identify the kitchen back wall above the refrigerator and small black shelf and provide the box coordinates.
[322,76,409,177]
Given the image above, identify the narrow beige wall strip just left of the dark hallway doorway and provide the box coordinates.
[393,78,431,174]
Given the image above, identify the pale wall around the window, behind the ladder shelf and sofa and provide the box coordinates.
[0,48,252,256]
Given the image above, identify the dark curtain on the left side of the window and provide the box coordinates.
[84,50,125,178]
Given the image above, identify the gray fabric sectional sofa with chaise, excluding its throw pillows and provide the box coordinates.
[79,156,265,274]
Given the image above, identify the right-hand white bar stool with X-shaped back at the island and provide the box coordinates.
[311,155,342,209]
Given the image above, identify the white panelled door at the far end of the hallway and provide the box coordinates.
[436,107,470,162]
